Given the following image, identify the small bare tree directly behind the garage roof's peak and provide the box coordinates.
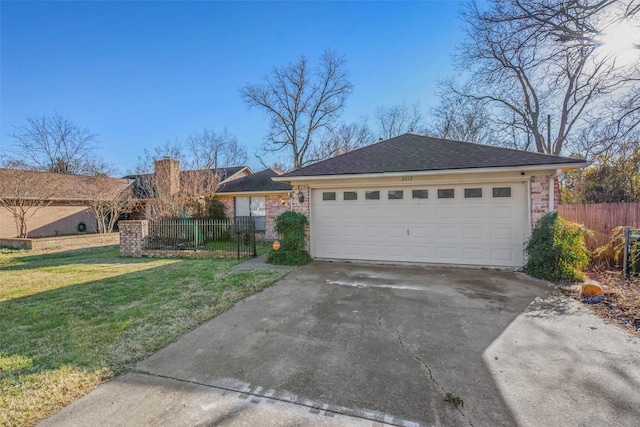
[375,101,424,139]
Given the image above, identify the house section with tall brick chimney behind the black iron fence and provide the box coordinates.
[125,158,253,219]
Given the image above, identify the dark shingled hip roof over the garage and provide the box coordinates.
[282,133,585,177]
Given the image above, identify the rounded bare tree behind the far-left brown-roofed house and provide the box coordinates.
[9,113,112,175]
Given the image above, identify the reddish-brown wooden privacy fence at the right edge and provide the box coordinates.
[558,202,640,250]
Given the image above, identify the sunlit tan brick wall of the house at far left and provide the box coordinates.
[0,203,98,238]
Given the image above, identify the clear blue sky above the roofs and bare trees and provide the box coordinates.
[0,1,463,174]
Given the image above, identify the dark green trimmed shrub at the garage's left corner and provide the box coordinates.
[267,211,311,265]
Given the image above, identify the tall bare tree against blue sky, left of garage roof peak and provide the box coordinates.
[240,51,352,169]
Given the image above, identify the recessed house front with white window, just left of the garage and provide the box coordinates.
[216,169,292,240]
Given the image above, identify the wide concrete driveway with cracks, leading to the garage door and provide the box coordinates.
[43,262,640,426]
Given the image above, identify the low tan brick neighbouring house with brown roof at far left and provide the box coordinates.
[0,169,131,238]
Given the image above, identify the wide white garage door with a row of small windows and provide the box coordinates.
[311,182,528,267]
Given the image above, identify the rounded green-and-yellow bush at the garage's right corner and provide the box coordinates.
[525,212,589,281]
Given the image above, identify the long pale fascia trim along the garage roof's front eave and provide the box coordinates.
[271,161,589,182]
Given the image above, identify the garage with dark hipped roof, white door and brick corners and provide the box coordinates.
[274,134,587,267]
